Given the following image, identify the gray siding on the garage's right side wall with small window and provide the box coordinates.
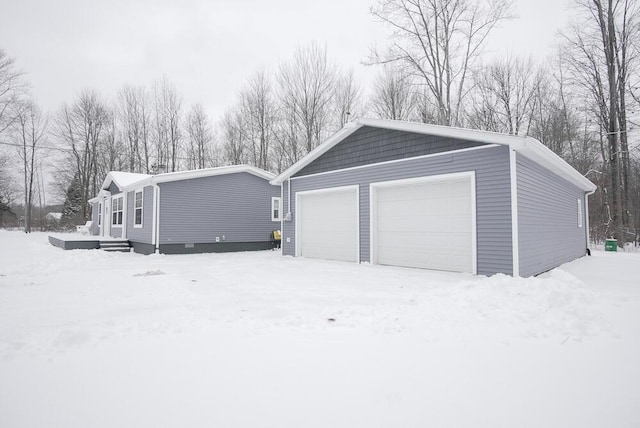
[516,154,587,276]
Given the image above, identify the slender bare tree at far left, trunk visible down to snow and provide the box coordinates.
[13,101,48,233]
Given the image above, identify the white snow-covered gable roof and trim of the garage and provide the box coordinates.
[271,118,596,192]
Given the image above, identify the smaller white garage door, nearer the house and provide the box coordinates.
[296,187,358,262]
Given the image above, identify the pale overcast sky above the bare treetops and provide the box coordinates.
[0,0,568,120]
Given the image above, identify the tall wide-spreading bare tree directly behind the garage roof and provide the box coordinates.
[371,0,510,126]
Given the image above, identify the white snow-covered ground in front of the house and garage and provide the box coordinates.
[0,231,640,428]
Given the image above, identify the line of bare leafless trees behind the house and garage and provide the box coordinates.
[0,0,640,243]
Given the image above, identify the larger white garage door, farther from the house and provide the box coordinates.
[372,174,475,273]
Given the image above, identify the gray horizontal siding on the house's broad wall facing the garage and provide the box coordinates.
[159,172,280,244]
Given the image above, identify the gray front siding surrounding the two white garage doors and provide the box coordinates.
[282,146,513,275]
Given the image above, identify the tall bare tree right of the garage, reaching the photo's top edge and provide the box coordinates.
[564,0,640,244]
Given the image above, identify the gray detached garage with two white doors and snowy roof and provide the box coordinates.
[271,119,596,276]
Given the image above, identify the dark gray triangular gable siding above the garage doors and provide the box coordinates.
[296,126,484,176]
